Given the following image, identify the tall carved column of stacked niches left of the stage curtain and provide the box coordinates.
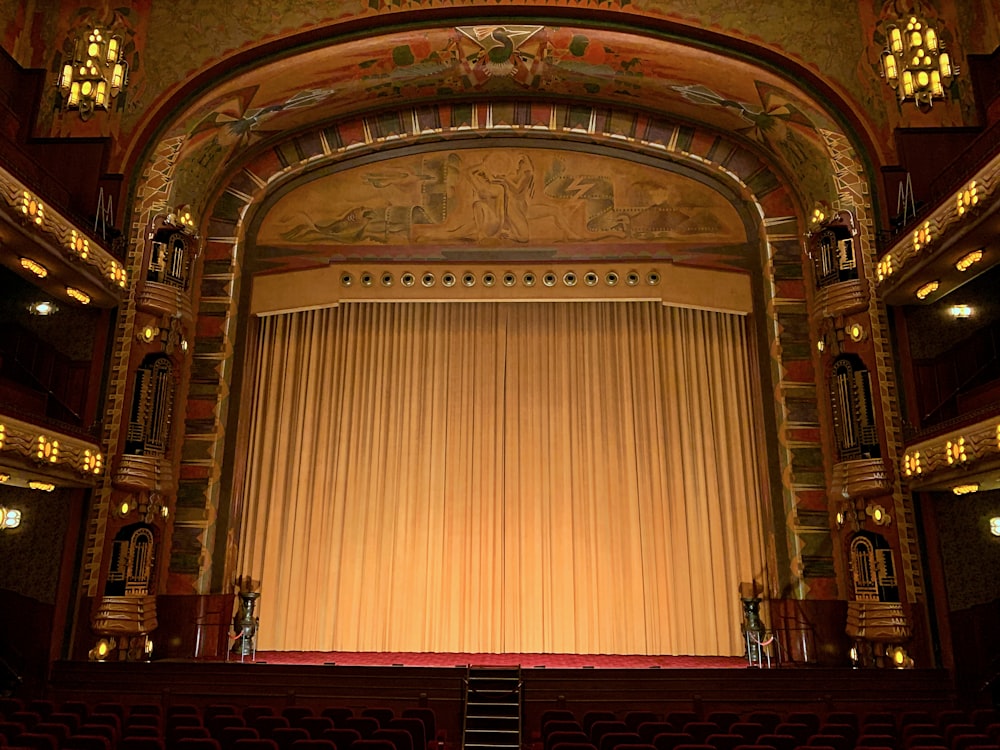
[90,209,197,661]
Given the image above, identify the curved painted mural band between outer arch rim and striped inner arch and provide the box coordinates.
[167,24,839,217]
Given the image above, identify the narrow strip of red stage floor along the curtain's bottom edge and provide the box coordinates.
[257,651,747,669]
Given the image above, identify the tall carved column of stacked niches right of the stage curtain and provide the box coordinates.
[809,211,912,666]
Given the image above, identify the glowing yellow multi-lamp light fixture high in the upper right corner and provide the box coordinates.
[882,16,958,110]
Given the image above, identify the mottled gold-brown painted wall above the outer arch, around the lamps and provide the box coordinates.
[0,0,1000,165]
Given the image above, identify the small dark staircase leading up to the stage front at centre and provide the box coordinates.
[463,667,521,750]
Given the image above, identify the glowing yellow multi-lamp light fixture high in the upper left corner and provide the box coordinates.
[59,26,128,120]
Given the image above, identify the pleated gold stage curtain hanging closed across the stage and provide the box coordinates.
[238,302,764,655]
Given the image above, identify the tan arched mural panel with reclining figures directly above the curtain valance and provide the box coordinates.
[254,147,749,268]
